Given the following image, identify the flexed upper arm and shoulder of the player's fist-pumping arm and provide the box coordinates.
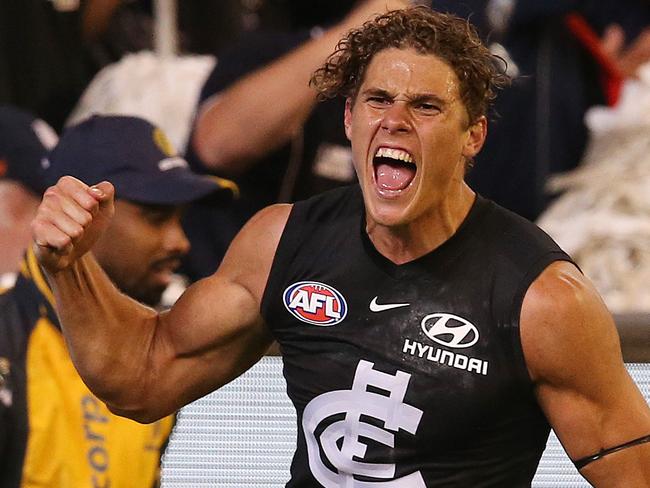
[126,206,290,422]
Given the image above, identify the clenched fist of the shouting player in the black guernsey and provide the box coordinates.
[32,176,115,273]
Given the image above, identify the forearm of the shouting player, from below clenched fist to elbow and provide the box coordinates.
[47,253,158,408]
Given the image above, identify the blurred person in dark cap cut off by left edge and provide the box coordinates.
[0,105,58,282]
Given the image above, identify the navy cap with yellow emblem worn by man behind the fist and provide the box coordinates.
[44,115,236,205]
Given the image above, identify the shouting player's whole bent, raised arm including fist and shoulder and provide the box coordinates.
[32,177,290,422]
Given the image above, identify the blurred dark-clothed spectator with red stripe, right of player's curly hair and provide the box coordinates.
[463,0,650,219]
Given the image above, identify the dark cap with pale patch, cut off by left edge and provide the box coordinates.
[0,105,58,195]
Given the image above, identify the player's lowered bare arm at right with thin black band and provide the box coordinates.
[521,262,650,488]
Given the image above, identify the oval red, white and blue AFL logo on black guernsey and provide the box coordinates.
[283,281,348,327]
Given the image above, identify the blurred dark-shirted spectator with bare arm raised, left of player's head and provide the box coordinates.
[184,0,409,279]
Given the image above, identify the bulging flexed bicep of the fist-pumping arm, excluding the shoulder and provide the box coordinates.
[154,275,271,406]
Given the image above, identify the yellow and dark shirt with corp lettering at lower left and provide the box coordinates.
[0,251,173,488]
